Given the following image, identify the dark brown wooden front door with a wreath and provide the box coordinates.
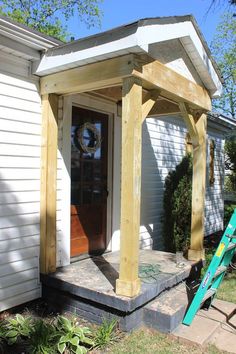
[71,107,108,257]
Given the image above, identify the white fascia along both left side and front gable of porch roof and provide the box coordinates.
[35,20,222,97]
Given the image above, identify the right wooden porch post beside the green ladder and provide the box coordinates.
[188,114,207,261]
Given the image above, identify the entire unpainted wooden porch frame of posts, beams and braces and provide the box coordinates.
[41,15,223,297]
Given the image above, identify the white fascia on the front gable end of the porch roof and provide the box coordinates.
[137,21,222,97]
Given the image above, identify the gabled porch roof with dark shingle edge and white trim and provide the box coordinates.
[35,15,222,97]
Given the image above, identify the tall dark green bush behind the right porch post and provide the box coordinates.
[163,154,192,252]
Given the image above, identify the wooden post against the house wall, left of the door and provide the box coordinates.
[40,94,58,274]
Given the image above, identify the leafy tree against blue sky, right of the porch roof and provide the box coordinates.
[211,12,236,118]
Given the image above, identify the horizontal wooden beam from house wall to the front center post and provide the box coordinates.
[40,54,135,95]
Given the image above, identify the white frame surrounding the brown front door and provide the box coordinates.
[58,94,117,266]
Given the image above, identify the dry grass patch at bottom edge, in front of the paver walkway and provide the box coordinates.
[106,328,224,354]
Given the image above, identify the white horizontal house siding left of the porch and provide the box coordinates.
[0,52,41,311]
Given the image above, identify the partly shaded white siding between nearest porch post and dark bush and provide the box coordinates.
[141,117,187,250]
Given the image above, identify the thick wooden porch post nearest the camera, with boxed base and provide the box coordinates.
[116,77,142,297]
